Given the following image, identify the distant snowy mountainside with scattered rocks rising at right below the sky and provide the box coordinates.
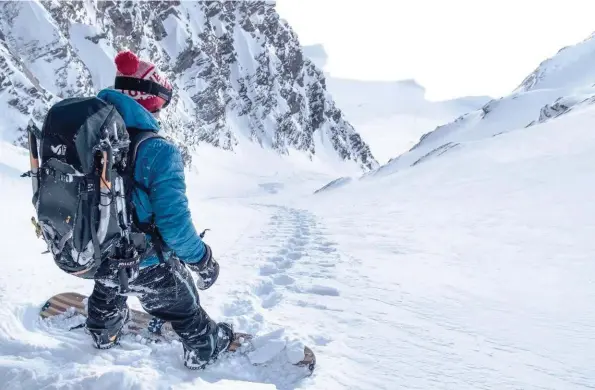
[372,32,595,178]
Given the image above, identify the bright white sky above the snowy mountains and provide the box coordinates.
[277,0,595,100]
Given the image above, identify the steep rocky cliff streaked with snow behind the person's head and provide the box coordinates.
[0,0,377,170]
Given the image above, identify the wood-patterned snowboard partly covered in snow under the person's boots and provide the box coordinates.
[39,292,316,375]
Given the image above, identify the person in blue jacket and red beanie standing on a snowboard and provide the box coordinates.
[86,51,233,369]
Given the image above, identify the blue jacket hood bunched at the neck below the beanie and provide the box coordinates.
[97,89,160,131]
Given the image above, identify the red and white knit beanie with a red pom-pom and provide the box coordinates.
[114,50,172,112]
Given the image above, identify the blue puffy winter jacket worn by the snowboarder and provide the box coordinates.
[97,89,206,267]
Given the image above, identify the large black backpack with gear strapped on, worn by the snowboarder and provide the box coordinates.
[24,97,158,288]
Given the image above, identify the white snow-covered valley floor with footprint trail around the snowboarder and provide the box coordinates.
[0,95,595,390]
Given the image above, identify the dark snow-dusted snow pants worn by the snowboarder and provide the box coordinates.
[87,261,218,361]
